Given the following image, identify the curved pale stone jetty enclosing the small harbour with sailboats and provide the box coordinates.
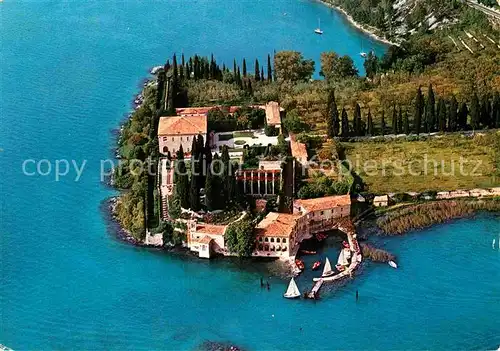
[307,218,363,299]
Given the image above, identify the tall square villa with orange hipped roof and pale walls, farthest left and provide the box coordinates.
[158,114,207,155]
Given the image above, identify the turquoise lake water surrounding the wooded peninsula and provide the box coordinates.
[0,0,500,350]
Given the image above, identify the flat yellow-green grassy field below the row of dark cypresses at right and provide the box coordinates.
[343,132,500,193]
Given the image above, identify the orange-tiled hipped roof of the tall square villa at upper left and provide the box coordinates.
[158,115,207,136]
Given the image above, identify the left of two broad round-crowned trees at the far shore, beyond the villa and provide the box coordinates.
[274,51,314,82]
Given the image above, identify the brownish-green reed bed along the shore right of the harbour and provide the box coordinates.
[377,198,500,235]
